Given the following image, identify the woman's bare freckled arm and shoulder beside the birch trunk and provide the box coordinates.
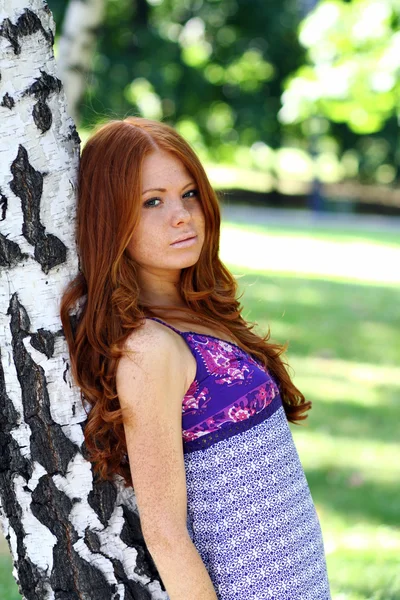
[117,321,217,600]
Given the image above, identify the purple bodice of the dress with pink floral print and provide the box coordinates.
[149,317,282,453]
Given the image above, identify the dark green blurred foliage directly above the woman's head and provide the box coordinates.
[49,0,304,163]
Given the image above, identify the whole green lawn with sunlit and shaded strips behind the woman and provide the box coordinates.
[0,218,400,600]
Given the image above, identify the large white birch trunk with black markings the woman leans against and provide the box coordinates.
[0,0,167,600]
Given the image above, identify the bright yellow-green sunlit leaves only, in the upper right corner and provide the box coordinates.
[281,0,400,134]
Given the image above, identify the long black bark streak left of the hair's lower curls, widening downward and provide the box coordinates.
[7,294,78,476]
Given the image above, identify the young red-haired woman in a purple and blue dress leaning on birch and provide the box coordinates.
[61,117,330,600]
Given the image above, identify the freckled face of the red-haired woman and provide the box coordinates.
[128,150,204,274]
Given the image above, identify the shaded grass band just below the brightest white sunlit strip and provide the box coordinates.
[238,268,400,366]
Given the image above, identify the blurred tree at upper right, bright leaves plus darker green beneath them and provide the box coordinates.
[280,0,400,184]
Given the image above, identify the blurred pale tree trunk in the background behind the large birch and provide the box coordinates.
[57,0,105,123]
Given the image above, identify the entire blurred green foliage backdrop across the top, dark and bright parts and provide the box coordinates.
[49,0,400,186]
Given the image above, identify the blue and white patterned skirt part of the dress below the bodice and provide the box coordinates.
[184,408,331,600]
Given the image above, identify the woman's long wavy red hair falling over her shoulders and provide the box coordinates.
[60,117,311,486]
